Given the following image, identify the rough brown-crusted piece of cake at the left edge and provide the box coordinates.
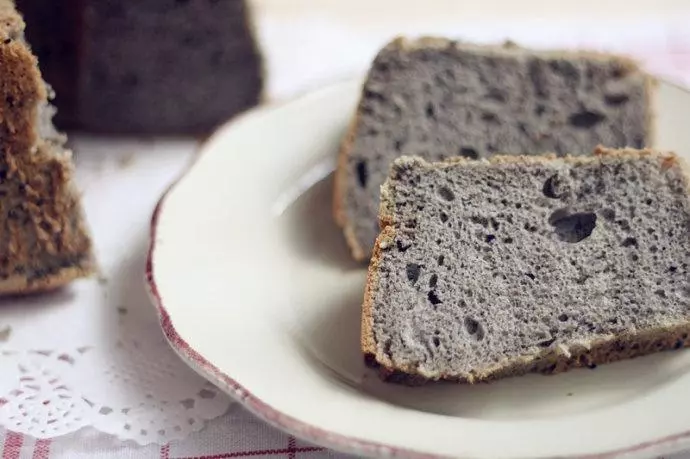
[0,0,93,293]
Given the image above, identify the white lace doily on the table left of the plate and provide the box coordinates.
[0,138,230,444]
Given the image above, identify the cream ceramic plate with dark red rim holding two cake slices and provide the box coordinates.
[147,82,690,458]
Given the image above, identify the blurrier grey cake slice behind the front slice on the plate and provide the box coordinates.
[334,38,652,260]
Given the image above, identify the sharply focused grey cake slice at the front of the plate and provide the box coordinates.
[362,148,690,383]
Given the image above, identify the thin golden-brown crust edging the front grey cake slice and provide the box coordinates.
[361,146,690,385]
